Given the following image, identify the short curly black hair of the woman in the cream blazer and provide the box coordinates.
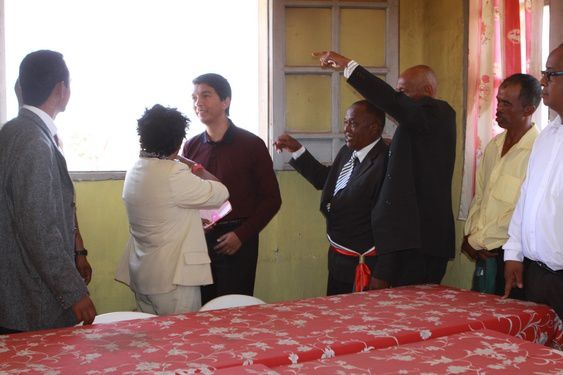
[137,104,190,158]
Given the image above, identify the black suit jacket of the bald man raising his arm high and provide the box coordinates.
[348,66,456,257]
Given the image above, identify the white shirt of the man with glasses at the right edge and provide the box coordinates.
[503,116,563,271]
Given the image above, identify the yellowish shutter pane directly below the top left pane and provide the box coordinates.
[285,75,331,133]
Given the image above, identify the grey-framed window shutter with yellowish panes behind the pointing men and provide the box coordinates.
[271,0,398,169]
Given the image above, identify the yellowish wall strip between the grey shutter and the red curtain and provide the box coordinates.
[399,0,475,288]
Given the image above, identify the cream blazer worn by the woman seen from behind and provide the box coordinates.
[115,158,229,294]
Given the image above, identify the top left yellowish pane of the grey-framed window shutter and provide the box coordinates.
[285,8,331,66]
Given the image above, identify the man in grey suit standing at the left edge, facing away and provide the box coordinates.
[0,50,96,334]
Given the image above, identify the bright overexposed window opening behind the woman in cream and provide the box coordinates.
[0,0,267,171]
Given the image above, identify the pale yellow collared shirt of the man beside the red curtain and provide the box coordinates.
[465,126,538,250]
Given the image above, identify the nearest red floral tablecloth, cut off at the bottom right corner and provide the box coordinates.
[270,330,563,375]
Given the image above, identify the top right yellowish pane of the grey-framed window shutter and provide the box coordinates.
[340,9,386,66]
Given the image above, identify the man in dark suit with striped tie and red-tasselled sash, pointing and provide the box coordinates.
[275,100,388,295]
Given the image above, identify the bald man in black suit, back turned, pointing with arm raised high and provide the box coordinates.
[313,51,456,286]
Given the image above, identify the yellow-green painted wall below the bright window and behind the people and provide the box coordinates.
[76,0,473,313]
